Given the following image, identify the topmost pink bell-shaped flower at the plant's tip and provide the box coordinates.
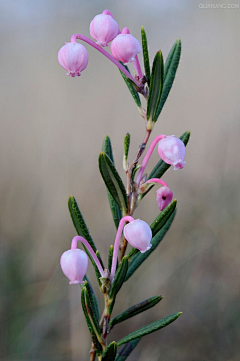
[89,10,119,46]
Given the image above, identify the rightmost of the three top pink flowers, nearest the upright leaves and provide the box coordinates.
[111,28,142,64]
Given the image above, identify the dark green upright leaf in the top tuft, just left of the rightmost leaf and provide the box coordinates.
[147,51,164,122]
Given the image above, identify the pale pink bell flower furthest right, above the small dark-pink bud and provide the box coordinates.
[158,135,186,170]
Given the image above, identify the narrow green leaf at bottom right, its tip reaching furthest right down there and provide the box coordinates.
[117,312,182,346]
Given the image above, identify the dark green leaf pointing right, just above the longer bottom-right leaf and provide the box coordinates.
[109,296,162,329]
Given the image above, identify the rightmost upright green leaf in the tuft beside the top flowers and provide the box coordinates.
[155,39,181,121]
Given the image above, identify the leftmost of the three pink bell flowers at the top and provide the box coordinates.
[58,43,88,77]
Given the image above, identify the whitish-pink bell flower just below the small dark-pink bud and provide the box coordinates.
[124,219,152,253]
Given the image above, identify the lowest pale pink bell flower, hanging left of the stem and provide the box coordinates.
[60,248,88,285]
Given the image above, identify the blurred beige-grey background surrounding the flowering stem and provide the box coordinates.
[0,0,240,361]
